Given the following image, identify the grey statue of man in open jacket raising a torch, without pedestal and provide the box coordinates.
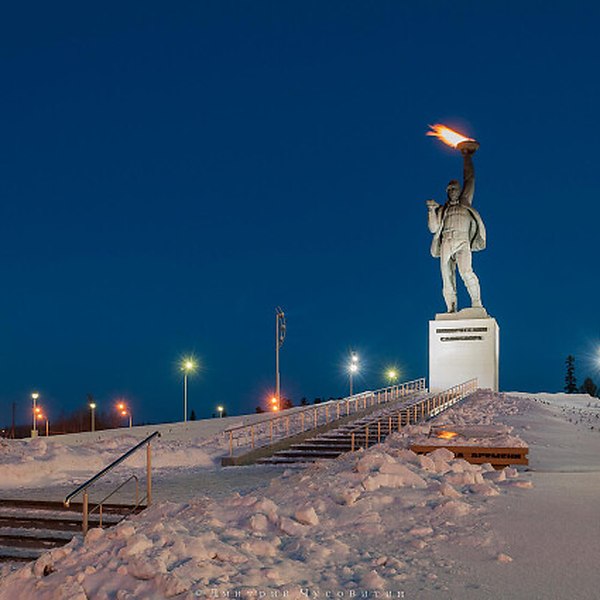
[427,141,485,313]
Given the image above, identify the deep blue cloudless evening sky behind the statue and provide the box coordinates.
[0,0,600,423]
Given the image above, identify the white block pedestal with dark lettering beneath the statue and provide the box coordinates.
[429,309,500,392]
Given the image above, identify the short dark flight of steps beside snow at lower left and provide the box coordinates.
[0,500,144,562]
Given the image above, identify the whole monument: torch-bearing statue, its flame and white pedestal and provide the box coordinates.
[427,125,500,392]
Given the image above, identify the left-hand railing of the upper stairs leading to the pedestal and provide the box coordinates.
[223,377,426,457]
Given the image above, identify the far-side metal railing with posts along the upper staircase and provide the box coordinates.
[223,378,425,456]
